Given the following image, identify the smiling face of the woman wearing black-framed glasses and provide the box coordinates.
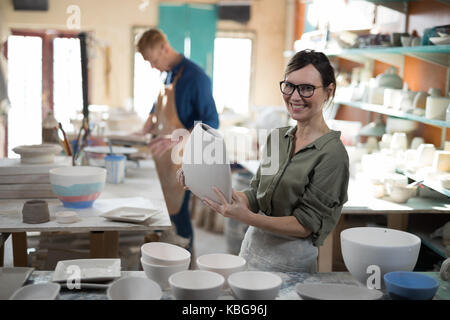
[283,64,333,121]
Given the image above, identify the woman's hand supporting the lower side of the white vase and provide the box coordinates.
[202,187,252,222]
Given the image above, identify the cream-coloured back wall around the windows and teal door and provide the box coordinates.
[0,0,285,111]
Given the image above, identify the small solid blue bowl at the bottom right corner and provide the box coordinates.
[384,271,439,300]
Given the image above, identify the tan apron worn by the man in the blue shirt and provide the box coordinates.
[151,68,185,215]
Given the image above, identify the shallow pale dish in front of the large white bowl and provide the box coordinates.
[295,283,383,300]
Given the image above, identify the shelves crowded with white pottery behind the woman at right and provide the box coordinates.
[327,45,450,202]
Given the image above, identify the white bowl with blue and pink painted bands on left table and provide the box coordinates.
[50,166,106,209]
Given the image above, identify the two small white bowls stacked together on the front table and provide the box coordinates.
[141,242,191,290]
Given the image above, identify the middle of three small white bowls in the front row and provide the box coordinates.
[169,270,225,300]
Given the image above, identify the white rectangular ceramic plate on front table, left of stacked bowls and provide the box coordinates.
[52,259,120,282]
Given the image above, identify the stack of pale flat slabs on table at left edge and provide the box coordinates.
[0,157,72,199]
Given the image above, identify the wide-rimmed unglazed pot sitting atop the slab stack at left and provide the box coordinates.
[13,143,62,164]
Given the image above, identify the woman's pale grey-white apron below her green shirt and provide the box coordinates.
[239,226,318,273]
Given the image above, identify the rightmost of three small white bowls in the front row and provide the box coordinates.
[228,271,283,300]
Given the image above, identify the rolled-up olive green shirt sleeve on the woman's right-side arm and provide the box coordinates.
[293,159,349,246]
